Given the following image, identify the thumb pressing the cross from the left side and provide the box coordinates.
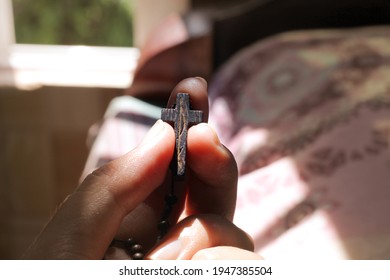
[25,121,174,259]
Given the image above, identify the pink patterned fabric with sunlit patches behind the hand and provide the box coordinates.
[210,27,390,259]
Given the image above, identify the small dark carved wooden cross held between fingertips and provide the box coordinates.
[161,93,203,177]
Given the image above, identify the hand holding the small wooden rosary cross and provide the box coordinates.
[25,78,253,259]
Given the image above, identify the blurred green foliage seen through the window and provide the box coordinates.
[12,0,133,46]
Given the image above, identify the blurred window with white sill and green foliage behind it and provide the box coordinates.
[0,0,139,88]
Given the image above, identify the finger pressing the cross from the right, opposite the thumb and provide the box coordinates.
[186,123,238,220]
